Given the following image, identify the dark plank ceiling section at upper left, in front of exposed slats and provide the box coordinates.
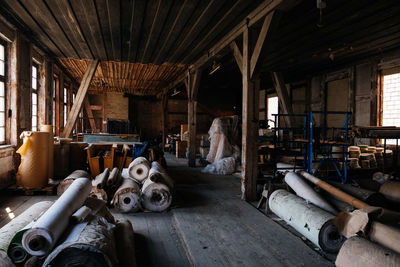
[0,0,262,65]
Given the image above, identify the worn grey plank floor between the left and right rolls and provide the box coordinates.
[0,154,333,267]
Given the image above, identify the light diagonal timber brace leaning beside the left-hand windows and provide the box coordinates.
[63,60,99,138]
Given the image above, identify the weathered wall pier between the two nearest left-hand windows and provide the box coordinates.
[8,33,32,147]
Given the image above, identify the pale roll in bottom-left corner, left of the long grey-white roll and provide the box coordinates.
[0,201,54,266]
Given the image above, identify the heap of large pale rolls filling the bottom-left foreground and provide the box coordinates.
[0,177,136,267]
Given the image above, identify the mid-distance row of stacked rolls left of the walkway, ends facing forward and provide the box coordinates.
[57,157,174,213]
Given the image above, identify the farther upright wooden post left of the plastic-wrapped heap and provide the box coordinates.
[186,70,201,167]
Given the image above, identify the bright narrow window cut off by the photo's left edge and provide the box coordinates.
[0,43,6,144]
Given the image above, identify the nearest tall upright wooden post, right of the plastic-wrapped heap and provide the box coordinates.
[242,27,260,201]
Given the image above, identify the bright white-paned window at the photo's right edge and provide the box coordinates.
[382,73,400,144]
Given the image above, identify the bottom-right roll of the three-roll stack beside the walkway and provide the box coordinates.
[142,179,172,212]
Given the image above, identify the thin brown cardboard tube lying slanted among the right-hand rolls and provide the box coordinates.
[300,171,369,209]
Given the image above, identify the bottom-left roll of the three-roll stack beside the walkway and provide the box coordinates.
[111,178,140,215]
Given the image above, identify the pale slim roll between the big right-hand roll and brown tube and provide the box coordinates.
[285,172,337,214]
